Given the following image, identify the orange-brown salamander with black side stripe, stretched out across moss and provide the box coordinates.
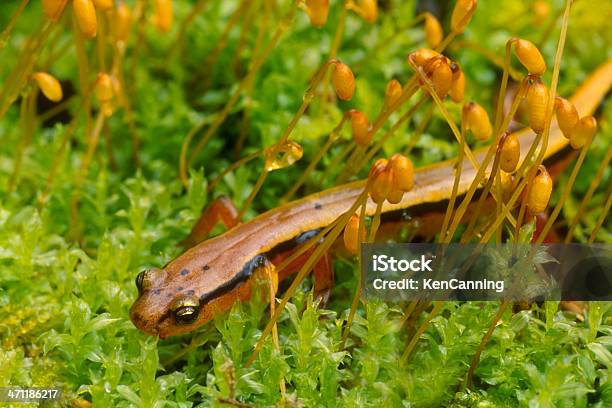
[130,60,612,338]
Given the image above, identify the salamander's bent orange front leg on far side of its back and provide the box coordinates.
[179,196,238,248]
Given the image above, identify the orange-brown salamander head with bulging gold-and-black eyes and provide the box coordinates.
[130,268,212,338]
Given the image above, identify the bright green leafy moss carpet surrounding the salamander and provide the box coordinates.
[0,0,612,407]
